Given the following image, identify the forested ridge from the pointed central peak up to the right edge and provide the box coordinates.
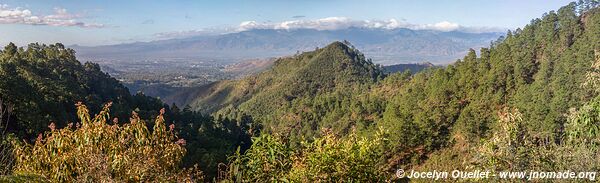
[190,0,599,144]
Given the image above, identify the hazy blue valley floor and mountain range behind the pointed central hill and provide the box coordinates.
[73,27,502,98]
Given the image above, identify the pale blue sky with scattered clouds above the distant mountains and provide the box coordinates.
[0,0,570,46]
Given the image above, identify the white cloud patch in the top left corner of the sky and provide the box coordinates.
[0,4,104,28]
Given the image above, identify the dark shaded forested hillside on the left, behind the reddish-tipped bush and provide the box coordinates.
[0,43,250,180]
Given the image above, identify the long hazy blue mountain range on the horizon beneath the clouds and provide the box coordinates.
[73,27,502,65]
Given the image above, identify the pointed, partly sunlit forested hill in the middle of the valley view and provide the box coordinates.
[186,42,384,137]
